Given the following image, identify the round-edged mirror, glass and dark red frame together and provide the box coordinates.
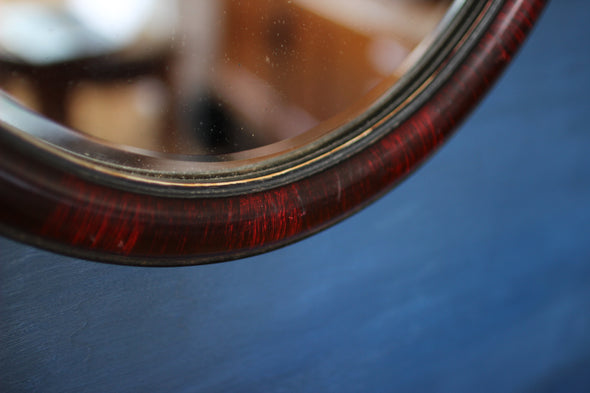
[0,0,545,266]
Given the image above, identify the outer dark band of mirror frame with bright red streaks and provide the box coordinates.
[0,0,546,266]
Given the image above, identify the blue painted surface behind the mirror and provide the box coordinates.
[0,0,590,392]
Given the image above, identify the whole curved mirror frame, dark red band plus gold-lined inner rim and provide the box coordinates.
[0,0,546,266]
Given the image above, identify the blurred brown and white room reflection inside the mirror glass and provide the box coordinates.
[0,0,452,155]
